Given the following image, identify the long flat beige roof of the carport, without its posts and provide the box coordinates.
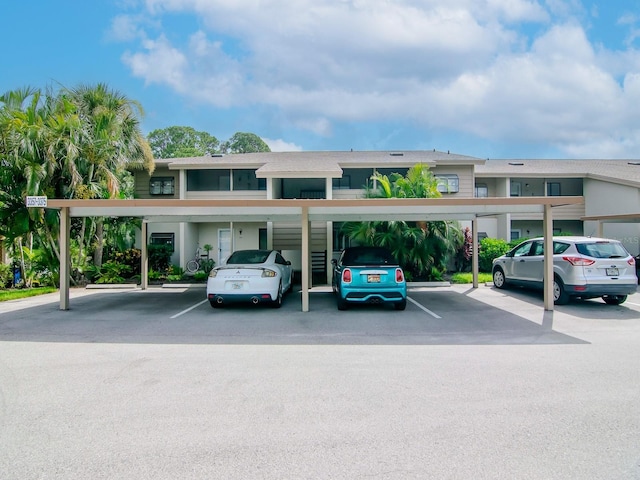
[48,197,584,223]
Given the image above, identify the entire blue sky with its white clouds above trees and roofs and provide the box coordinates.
[0,0,640,159]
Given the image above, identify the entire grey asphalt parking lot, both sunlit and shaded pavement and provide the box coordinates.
[0,285,640,479]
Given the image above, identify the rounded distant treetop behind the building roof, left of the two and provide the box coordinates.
[147,126,220,158]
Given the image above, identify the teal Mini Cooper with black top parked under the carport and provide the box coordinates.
[331,247,407,310]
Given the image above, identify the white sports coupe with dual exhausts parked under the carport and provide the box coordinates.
[207,250,293,308]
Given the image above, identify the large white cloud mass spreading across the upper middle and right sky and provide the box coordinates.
[114,0,640,154]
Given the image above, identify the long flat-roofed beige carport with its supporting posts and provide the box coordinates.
[47,196,584,312]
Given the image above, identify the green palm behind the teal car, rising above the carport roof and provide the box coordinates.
[342,164,462,280]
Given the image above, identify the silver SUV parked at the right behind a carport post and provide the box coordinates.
[492,237,638,305]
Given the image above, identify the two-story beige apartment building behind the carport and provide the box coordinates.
[135,150,640,278]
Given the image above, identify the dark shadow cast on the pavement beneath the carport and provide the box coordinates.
[0,289,592,345]
